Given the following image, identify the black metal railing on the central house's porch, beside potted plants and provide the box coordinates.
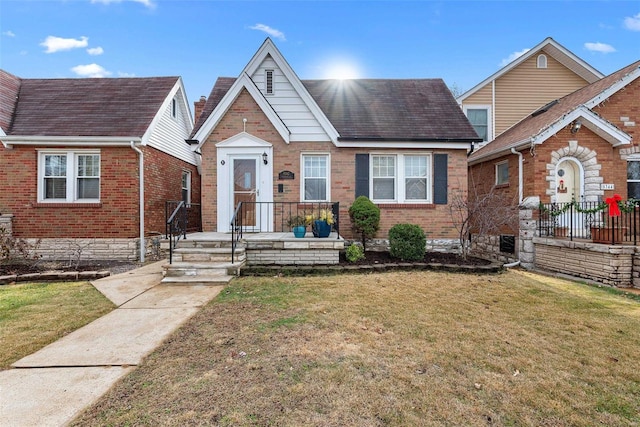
[231,202,340,262]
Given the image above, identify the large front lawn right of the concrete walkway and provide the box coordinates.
[75,271,640,426]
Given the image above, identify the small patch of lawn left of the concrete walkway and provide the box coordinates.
[0,282,114,369]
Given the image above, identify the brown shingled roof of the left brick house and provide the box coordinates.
[0,72,185,138]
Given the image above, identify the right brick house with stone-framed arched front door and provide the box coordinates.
[469,61,640,260]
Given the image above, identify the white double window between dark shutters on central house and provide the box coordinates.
[370,154,432,203]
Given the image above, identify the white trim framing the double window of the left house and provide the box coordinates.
[37,149,102,203]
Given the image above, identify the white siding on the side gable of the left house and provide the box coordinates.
[148,90,196,164]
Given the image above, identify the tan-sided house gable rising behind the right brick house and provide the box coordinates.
[457,37,604,149]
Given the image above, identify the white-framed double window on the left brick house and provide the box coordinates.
[38,151,100,203]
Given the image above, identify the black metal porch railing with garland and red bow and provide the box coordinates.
[537,200,640,245]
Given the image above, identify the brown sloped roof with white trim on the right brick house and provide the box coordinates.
[469,61,640,164]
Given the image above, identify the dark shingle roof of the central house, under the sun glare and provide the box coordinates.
[193,77,479,142]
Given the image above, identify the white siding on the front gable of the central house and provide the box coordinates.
[251,56,330,141]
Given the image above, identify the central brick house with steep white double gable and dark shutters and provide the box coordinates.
[191,39,479,247]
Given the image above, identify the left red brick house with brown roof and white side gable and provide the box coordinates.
[0,70,200,259]
